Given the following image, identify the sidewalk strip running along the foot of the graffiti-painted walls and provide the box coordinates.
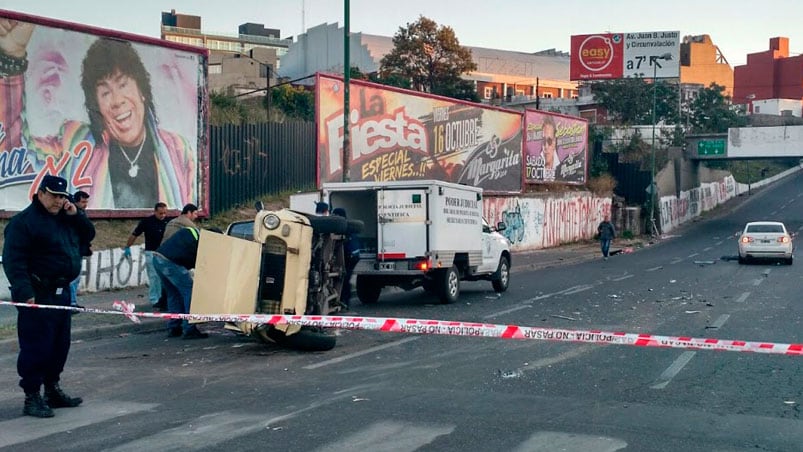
[0,240,642,349]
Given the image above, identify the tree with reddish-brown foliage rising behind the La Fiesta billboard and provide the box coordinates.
[379,16,477,99]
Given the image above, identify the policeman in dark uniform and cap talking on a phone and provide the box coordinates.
[3,175,95,417]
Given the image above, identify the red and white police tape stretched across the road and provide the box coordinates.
[0,301,803,356]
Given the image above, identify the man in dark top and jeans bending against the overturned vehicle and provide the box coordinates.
[153,227,221,339]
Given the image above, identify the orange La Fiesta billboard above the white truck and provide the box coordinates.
[316,74,522,193]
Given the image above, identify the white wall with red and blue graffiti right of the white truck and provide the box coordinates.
[483,194,611,251]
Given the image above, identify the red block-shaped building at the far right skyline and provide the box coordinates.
[733,37,803,113]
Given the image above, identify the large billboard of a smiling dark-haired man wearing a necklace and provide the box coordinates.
[0,10,208,216]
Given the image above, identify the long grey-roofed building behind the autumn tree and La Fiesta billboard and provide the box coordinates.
[278,23,578,105]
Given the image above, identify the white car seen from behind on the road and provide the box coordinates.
[739,221,794,265]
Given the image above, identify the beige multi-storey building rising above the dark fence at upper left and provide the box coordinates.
[161,10,293,95]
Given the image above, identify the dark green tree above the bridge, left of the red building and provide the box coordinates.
[689,83,745,133]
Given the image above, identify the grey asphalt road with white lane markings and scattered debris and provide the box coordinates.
[0,175,803,451]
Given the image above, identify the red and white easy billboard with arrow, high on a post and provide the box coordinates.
[569,31,680,80]
